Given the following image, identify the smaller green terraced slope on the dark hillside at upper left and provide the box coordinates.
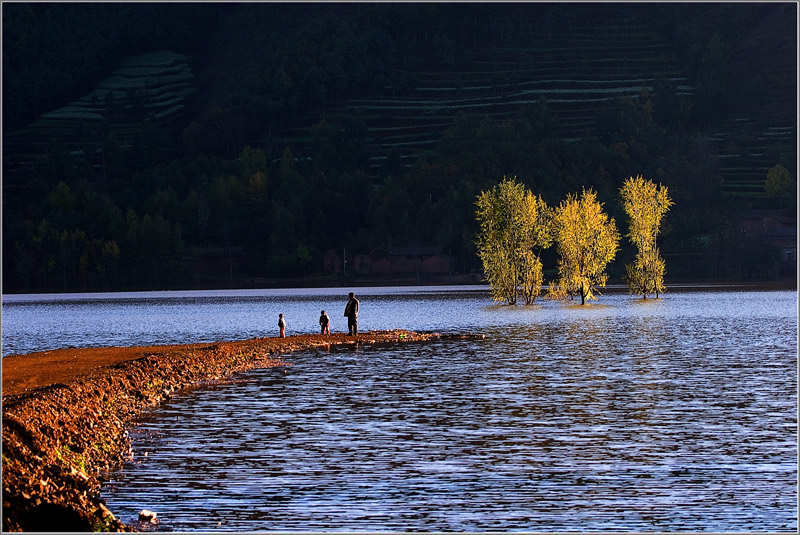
[3,50,197,177]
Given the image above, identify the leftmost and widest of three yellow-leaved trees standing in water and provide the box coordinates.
[475,178,553,305]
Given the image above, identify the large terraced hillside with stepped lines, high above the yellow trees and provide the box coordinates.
[270,14,692,176]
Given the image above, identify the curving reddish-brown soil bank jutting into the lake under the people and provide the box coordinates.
[2,330,480,531]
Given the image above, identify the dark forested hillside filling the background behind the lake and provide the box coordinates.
[2,3,797,293]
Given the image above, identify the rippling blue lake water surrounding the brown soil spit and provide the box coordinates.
[3,287,798,532]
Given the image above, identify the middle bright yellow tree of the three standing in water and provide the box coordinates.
[550,189,619,304]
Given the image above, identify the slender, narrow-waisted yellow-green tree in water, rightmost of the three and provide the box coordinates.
[619,175,673,299]
